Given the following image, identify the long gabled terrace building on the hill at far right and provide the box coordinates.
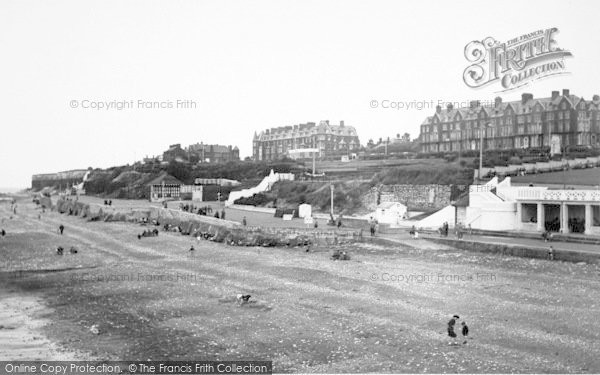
[420,90,600,153]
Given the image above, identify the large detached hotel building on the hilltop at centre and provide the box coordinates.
[252,120,360,160]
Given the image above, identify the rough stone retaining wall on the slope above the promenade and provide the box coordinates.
[363,184,452,211]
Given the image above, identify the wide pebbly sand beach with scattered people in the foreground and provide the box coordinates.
[0,197,600,373]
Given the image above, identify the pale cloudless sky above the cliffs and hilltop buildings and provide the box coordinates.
[0,0,600,188]
